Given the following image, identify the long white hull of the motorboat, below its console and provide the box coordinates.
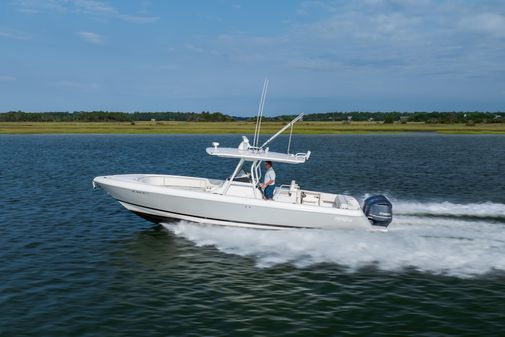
[93,175,372,229]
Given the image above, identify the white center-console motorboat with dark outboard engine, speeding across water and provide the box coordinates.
[93,82,393,230]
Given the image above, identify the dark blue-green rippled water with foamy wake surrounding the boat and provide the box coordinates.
[0,134,505,337]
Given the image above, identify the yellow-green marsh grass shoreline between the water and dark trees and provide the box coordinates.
[0,121,505,135]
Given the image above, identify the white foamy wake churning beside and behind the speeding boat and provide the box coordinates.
[160,201,505,277]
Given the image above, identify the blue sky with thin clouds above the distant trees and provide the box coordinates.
[0,0,505,116]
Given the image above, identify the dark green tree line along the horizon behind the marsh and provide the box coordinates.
[0,111,505,124]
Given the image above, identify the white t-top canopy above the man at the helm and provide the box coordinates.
[207,146,310,164]
